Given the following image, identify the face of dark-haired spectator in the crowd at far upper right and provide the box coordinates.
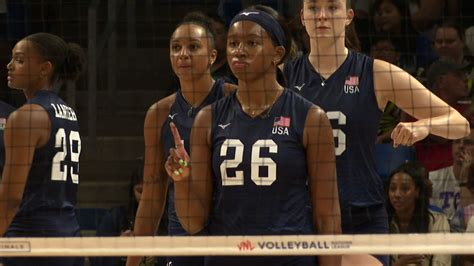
[434,27,464,59]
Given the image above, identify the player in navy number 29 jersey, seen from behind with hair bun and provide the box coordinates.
[0,33,85,266]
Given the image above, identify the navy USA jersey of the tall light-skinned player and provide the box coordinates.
[284,51,384,209]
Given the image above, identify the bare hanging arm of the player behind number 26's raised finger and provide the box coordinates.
[127,98,174,266]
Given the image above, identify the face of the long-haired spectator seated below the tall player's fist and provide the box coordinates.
[388,173,419,213]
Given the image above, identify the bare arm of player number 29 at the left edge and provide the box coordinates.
[0,104,51,235]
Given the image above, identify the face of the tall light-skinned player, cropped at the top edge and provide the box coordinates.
[300,0,354,41]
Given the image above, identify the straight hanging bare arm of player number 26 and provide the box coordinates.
[304,107,342,265]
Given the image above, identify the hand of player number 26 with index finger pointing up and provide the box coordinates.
[165,122,190,182]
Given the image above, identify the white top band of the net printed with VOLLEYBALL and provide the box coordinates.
[0,233,474,257]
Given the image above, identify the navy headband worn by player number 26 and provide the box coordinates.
[230,10,287,46]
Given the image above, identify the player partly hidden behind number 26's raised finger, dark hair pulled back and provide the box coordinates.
[127,12,232,266]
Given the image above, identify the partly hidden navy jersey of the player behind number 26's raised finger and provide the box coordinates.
[161,79,224,235]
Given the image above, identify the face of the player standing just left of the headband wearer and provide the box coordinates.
[170,24,217,80]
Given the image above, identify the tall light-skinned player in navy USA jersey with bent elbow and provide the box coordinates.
[284,0,469,265]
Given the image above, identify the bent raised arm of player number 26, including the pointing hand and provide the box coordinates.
[166,106,212,234]
